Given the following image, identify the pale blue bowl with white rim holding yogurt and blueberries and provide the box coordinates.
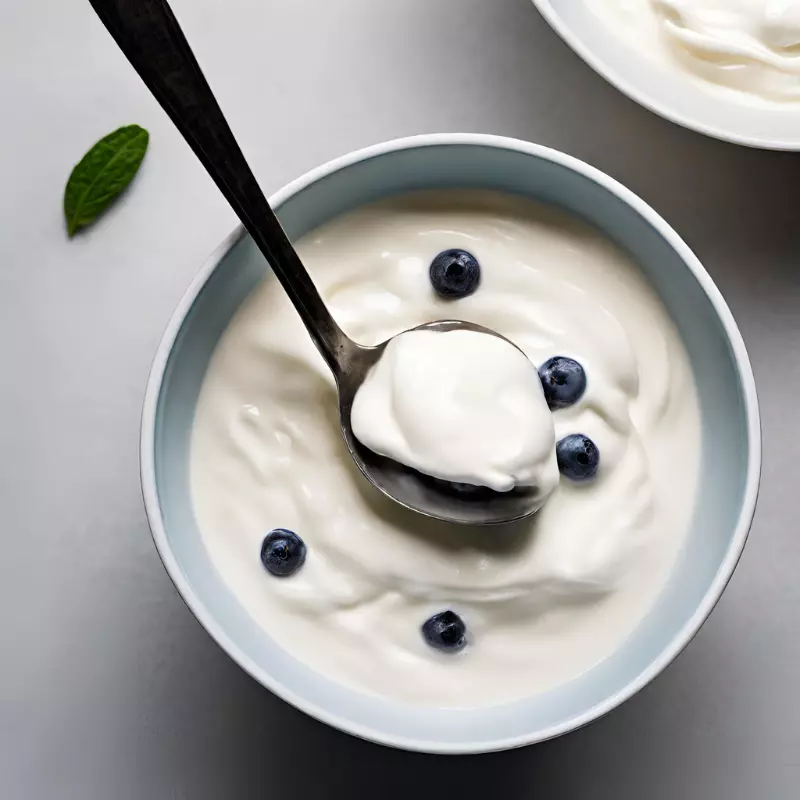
[141,134,761,753]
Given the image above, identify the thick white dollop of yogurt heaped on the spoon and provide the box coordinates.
[351,330,558,502]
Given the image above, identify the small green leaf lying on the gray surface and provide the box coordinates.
[64,125,150,236]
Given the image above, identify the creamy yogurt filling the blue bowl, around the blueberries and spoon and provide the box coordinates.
[191,191,700,707]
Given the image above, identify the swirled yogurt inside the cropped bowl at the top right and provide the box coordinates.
[586,0,800,102]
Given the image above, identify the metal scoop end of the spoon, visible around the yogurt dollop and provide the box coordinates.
[334,320,542,525]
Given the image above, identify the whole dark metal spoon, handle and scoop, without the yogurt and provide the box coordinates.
[89,0,539,525]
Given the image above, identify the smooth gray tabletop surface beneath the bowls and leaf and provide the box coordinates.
[0,0,800,800]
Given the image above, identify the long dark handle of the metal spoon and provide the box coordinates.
[89,0,358,380]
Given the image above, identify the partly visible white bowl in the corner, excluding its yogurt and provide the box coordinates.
[533,0,800,150]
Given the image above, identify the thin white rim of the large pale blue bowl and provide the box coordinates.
[139,133,761,755]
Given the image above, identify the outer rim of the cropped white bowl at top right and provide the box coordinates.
[531,0,800,151]
